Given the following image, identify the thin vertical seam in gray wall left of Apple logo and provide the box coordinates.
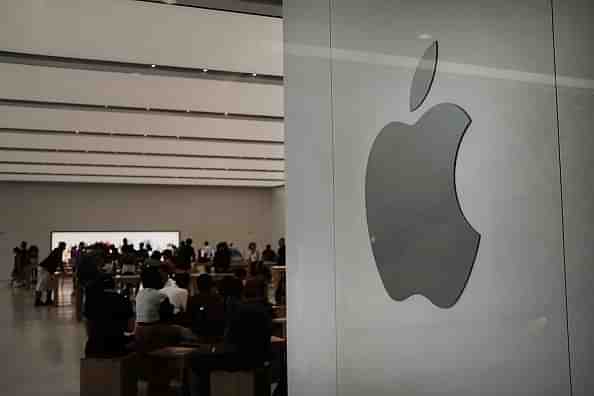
[328,0,340,396]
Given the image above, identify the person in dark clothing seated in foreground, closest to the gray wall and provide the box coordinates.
[190,280,272,395]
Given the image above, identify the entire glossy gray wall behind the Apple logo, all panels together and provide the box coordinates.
[285,0,594,396]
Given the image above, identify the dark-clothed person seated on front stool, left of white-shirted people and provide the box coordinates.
[84,274,134,358]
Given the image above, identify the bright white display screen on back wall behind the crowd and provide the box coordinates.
[51,231,179,251]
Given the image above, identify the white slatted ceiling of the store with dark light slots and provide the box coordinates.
[0,0,285,187]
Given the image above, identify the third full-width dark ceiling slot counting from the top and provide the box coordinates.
[0,128,284,146]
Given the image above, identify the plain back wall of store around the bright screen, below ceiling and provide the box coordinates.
[0,183,274,279]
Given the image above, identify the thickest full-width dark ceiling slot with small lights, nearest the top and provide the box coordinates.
[0,50,283,85]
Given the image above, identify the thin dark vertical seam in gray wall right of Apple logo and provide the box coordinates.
[550,0,573,395]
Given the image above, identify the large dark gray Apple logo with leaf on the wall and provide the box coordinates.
[365,41,480,308]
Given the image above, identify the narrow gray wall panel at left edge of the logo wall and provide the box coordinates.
[284,0,336,396]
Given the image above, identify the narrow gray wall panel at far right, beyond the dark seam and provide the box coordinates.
[554,0,594,396]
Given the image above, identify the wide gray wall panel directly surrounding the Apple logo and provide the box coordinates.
[330,0,569,396]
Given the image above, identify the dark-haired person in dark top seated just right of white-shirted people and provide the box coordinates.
[186,274,225,337]
